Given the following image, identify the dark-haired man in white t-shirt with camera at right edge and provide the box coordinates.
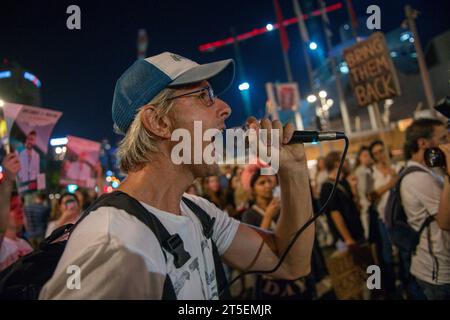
[400,119,450,300]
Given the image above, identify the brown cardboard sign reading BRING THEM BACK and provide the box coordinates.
[344,32,401,107]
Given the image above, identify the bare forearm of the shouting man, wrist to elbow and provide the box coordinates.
[274,163,314,278]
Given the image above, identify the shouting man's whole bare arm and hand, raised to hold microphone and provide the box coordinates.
[224,119,314,279]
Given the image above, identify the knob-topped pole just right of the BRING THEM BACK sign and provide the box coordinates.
[405,5,436,115]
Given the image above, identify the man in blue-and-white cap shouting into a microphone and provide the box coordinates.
[40,52,314,300]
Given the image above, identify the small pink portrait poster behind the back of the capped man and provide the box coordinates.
[60,136,101,188]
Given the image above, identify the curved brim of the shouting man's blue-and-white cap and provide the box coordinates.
[169,59,234,94]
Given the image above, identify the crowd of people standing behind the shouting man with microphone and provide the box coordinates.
[0,119,450,299]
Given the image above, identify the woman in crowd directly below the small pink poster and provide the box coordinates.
[45,193,81,237]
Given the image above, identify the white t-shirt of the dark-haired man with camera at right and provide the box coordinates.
[400,161,450,284]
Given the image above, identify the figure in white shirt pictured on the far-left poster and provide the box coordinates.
[18,130,40,183]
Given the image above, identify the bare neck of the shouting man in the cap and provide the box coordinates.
[119,161,194,215]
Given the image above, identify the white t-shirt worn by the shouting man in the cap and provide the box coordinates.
[40,194,239,299]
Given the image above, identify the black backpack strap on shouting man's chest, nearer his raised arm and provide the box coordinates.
[182,197,231,299]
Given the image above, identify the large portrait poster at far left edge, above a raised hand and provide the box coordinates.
[3,103,62,194]
